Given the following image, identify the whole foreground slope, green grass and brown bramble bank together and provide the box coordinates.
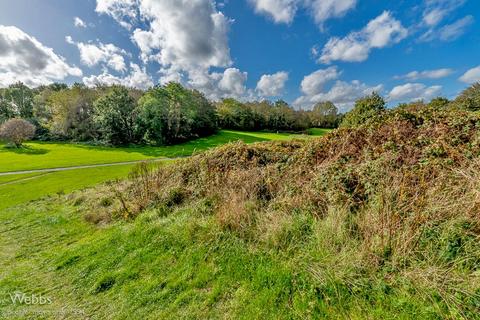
[0,107,480,319]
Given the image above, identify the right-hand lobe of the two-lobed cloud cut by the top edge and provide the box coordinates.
[305,0,357,26]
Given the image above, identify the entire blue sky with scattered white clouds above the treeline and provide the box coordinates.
[0,0,480,110]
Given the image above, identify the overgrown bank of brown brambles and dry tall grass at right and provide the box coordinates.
[89,103,480,319]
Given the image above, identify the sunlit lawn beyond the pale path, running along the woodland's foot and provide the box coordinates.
[0,130,330,172]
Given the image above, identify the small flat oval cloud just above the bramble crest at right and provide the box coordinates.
[388,83,442,102]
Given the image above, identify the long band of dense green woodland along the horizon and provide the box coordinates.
[0,82,480,145]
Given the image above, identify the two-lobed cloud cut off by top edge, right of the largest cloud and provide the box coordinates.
[249,0,357,26]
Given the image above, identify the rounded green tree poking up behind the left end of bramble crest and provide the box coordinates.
[341,92,386,127]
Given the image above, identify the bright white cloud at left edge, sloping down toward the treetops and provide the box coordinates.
[0,25,82,87]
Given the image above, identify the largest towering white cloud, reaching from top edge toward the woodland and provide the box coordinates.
[96,0,242,99]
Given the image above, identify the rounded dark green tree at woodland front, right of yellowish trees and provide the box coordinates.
[93,86,139,145]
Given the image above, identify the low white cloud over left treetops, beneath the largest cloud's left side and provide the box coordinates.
[83,63,153,89]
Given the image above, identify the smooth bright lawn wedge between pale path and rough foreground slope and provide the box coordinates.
[0,165,134,209]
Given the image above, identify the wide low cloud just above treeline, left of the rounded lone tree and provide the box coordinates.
[293,67,383,112]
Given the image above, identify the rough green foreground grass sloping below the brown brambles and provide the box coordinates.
[0,196,454,319]
